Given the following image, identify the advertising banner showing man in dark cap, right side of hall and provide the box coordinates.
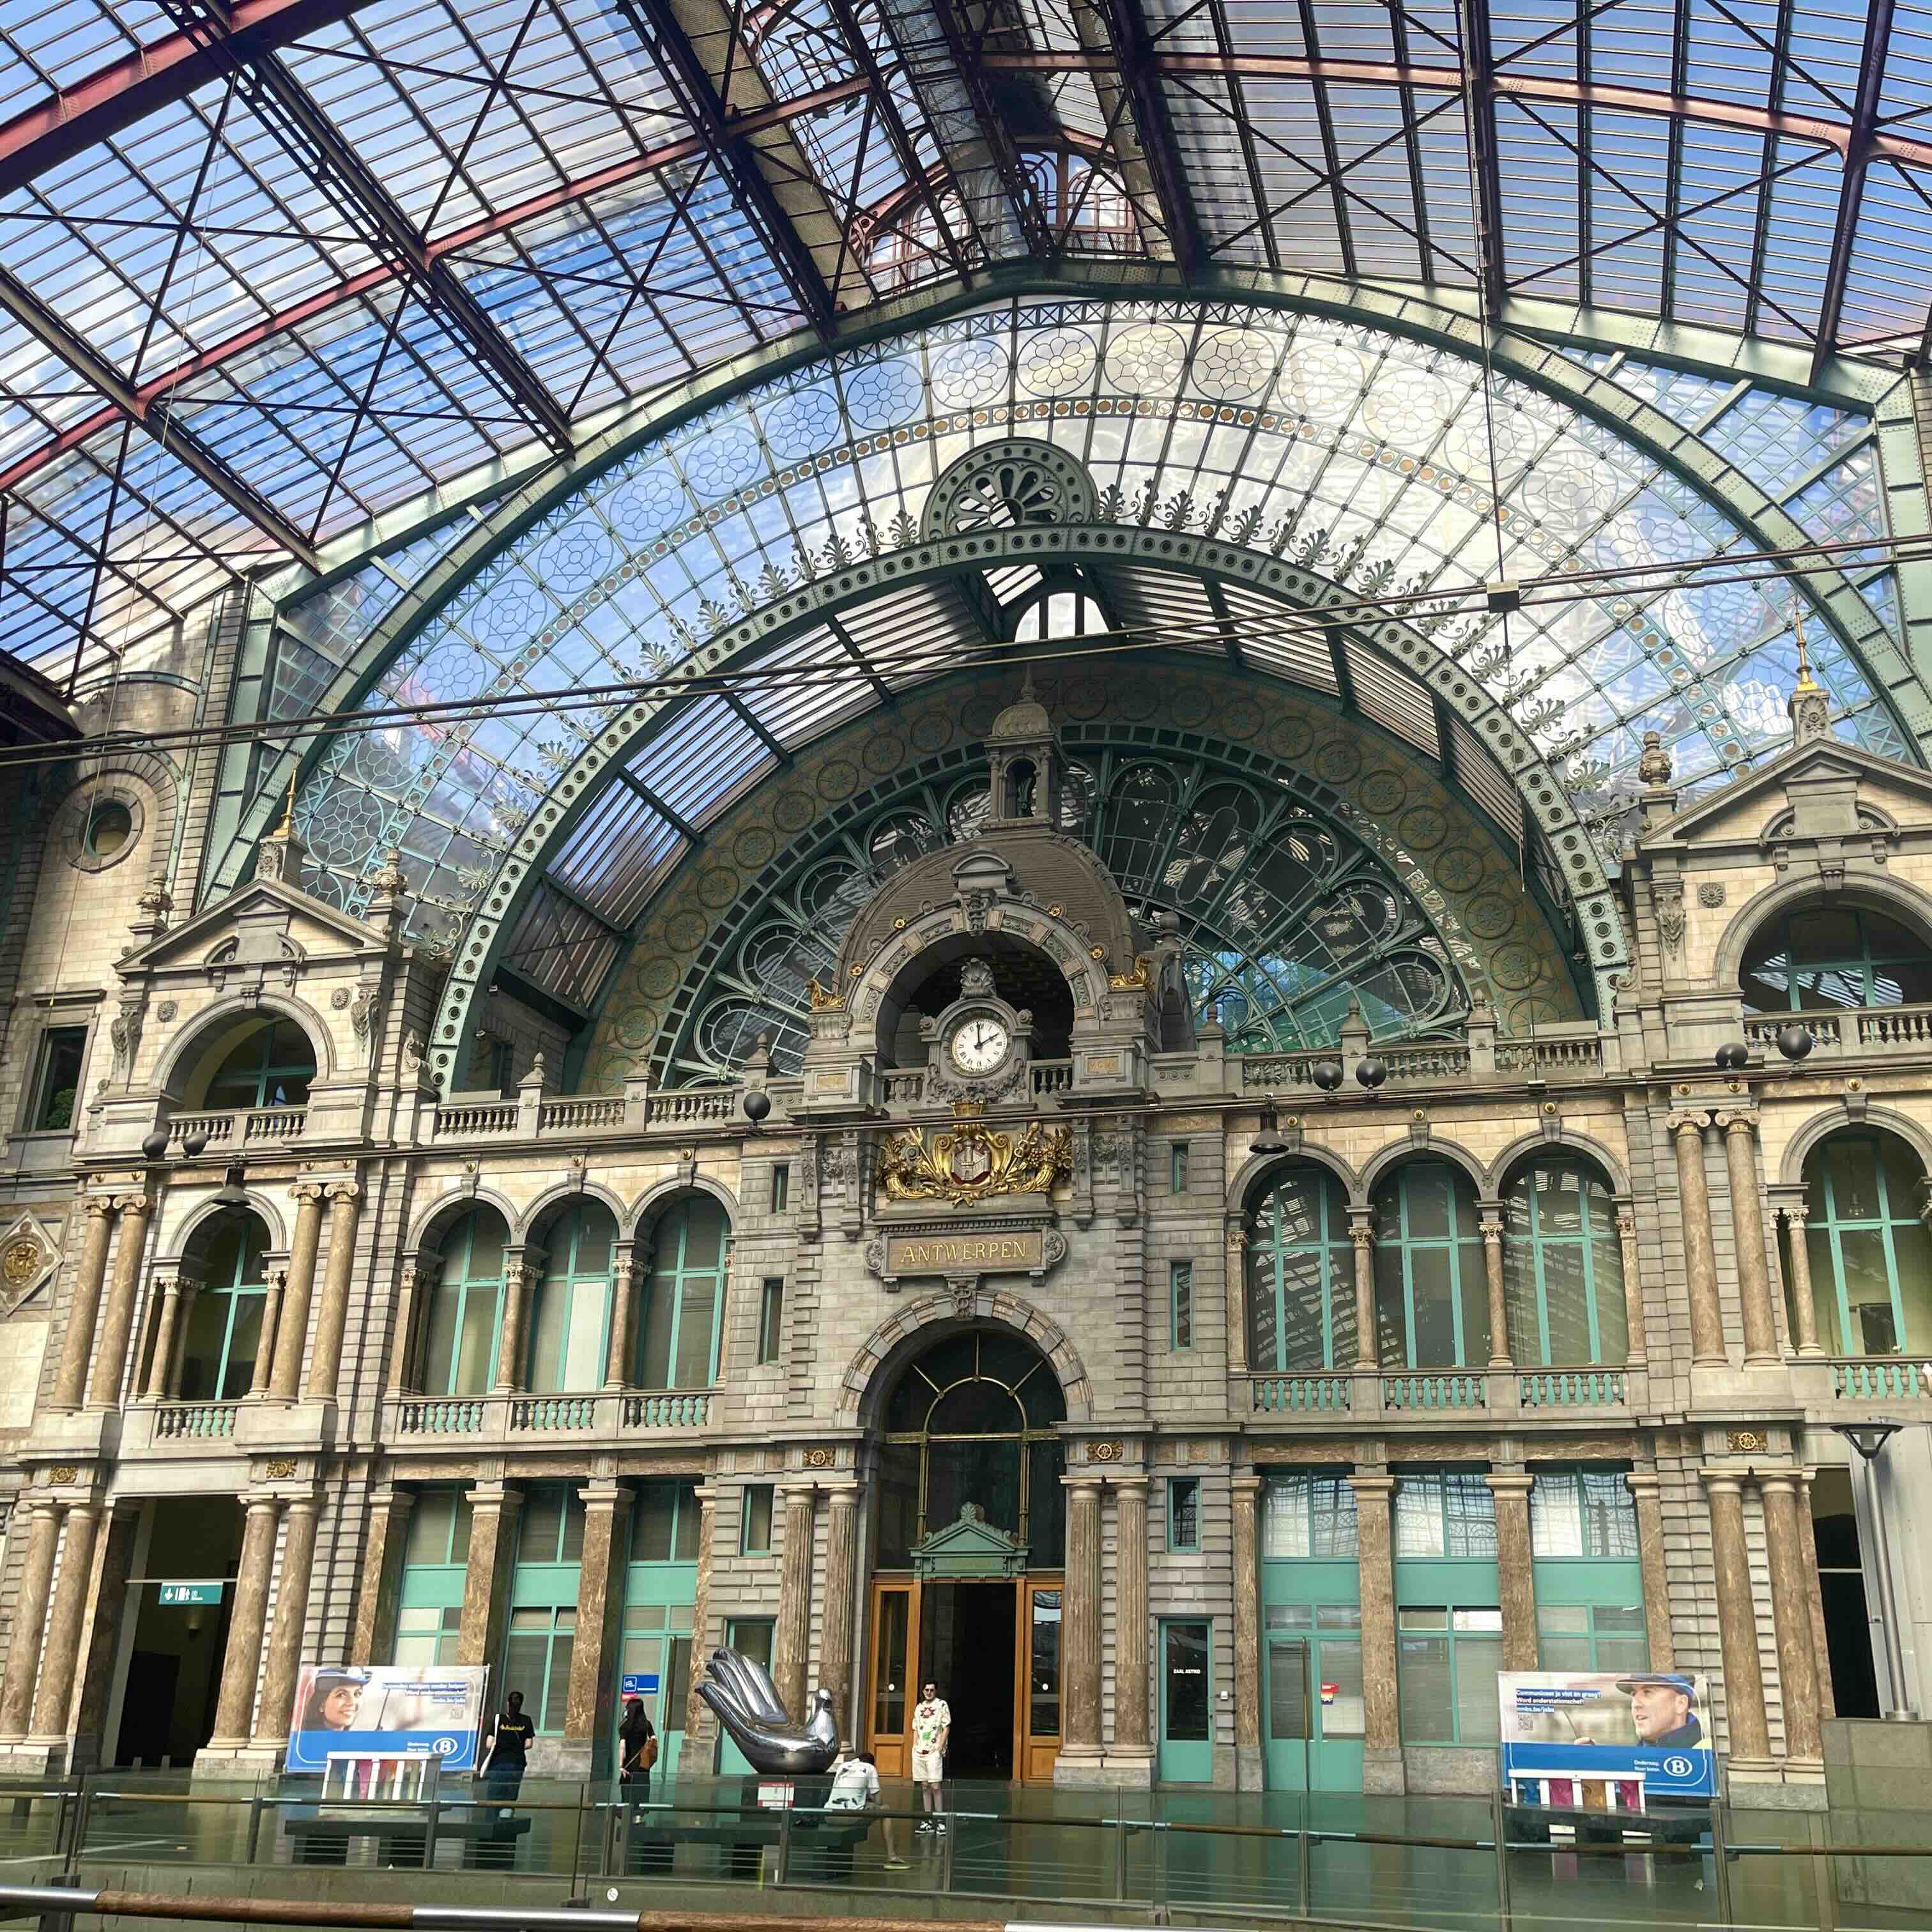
[1498,1671,1717,1810]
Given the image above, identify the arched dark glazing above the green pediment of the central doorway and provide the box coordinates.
[879,1330,1066,1568]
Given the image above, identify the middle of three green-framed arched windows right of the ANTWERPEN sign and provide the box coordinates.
[1372,1161,1490,1368]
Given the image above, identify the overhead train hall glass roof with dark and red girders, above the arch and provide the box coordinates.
[0,0,1932,688]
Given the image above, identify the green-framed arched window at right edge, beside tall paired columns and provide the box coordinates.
[1785,1128,1932,1354]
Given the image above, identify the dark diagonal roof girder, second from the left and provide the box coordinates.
[151,0,572,452]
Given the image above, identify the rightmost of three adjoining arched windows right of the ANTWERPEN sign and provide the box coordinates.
[1503,1157,1630,1366]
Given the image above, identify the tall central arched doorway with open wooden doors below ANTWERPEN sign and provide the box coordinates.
[866,1327,1066,1783]
